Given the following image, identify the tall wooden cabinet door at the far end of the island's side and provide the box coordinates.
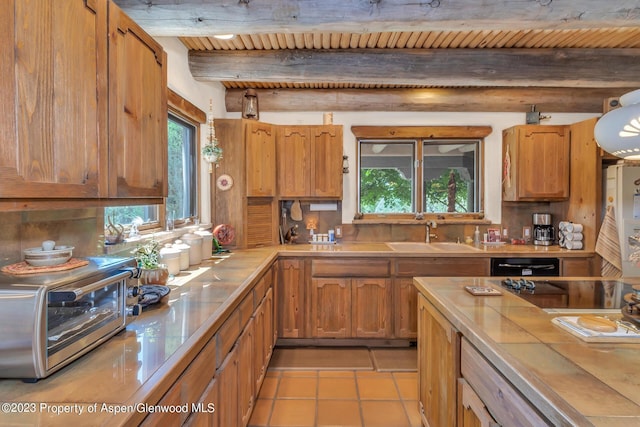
[418,295,460,427]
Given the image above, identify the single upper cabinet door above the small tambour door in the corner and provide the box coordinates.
[245,120,276,197]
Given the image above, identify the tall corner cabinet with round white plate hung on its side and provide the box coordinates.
[211,119,279,248]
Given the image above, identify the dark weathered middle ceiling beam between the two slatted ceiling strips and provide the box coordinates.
[189,49,640,88]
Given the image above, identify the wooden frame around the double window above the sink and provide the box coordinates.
[351,126,492,223]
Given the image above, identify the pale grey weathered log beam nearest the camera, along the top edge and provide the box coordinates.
[115,0,640,36]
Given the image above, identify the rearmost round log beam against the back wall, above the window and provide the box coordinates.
[225,88,630,113]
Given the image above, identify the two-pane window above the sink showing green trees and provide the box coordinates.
[358,139,482,215]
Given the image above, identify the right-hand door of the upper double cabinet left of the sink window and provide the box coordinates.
[310,126,342,199]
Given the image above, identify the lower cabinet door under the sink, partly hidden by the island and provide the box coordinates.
[393,277,418,339]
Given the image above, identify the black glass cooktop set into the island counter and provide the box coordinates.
[500,277,633,309]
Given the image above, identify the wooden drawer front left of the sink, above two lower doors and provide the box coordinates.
[311,259,390,277]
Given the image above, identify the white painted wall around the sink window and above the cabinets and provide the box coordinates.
[158,38,600,227]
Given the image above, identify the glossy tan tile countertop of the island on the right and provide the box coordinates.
[414,277,640,427]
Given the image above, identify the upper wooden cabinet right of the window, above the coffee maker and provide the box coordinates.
[502,125,571,201]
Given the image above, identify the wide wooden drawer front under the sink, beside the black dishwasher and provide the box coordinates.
[396,257,490,277]
